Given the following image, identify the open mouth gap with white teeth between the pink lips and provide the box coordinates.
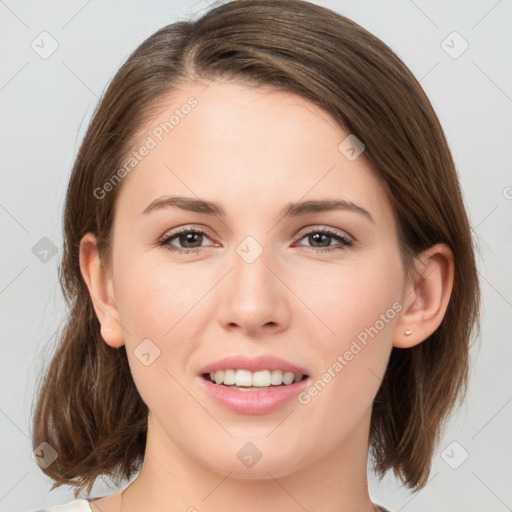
[202,369,309,391]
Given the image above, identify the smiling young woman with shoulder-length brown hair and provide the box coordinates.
[33,0,479,512]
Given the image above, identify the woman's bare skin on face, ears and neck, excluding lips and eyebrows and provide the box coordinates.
[80,82,453,512]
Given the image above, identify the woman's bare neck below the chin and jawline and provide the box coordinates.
[120,408,376,512]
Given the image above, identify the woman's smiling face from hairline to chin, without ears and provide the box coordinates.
[106,82,405,478]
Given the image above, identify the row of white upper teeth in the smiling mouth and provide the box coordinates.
[210,370,303,388]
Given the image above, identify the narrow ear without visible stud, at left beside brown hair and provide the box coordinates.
[80,233,124,348]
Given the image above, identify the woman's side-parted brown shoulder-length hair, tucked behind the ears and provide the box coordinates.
[33,0,480,496]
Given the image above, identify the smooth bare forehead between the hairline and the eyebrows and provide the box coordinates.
[115,82,391,228]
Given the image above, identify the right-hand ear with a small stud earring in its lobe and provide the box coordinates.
[393,244,454,348]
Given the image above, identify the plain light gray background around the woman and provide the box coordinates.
[0,0,512,512]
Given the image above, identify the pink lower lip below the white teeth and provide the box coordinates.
[197,375,309,414]
